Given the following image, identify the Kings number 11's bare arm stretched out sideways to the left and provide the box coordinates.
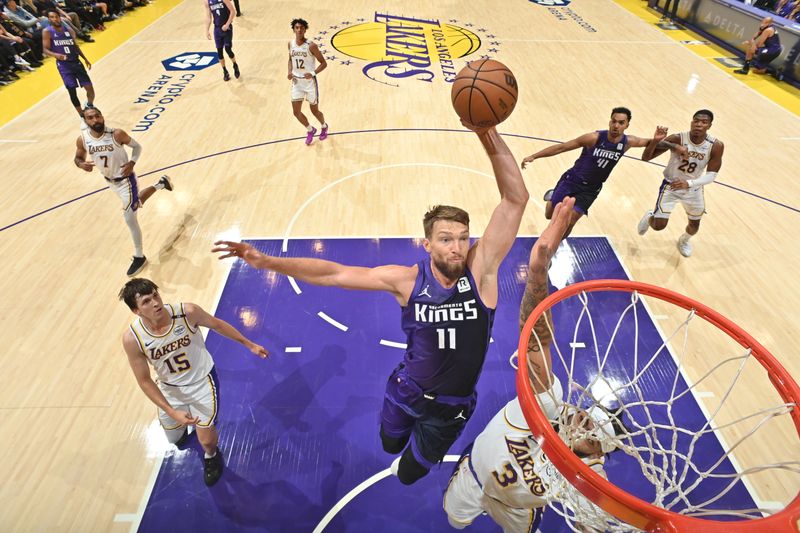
[211,241,417,306]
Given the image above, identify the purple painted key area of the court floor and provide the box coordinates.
[139,237,755,533]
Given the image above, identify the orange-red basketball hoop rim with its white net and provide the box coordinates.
[517,280,800,533]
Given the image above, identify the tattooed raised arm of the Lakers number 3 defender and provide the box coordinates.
[519,197,575,394]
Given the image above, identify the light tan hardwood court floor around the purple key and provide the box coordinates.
[0,0,800,531]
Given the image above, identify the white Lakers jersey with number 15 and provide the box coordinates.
[130,304,214,385]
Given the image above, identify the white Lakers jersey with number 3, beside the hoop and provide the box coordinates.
[470,398,605,509]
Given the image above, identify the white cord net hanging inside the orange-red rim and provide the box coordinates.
[520,284,800,531]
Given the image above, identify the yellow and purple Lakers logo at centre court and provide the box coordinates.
[324,12,501,87]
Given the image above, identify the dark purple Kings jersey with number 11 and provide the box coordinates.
[402,258,494,396]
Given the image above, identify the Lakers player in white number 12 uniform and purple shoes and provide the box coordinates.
[287,19,328,145]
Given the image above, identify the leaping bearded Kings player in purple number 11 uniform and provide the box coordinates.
[213,124,528,485]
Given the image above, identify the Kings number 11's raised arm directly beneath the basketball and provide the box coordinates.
[467,127,528,307]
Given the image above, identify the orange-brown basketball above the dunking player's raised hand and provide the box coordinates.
[450,59,517,128]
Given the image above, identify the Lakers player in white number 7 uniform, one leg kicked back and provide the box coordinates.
[74,107,172,276]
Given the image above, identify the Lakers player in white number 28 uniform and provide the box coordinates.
[637,109,725,257]
